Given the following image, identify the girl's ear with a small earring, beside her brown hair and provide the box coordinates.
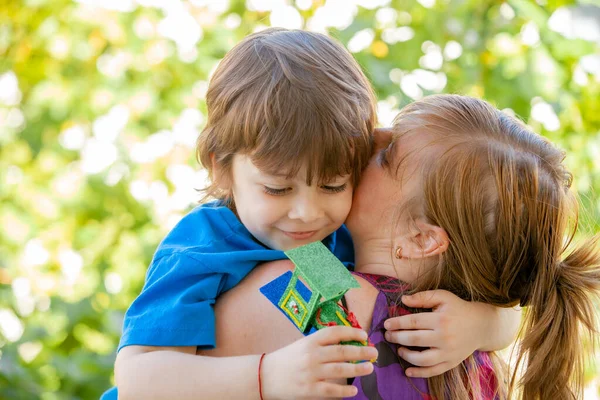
[397,219,450,259]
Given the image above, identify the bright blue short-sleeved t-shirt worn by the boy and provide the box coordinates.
[102,202,354,400]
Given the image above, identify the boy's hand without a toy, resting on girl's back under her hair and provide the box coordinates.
[385,290,496,378]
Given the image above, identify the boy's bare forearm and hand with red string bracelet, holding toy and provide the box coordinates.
[116,332,377,400]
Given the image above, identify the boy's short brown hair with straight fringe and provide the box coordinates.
[196,28,376,201]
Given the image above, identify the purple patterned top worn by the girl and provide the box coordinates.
[352,272,495,400]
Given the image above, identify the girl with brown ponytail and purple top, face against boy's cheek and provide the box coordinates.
[210,95,600,400]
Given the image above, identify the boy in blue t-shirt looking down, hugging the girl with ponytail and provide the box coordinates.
[103,29,376,399]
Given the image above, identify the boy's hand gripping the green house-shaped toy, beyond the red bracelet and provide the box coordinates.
[260,326,377,400]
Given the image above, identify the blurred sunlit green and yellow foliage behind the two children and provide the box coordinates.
[0,0,600,400]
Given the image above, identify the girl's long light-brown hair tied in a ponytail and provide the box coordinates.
[392,95,600,400]
